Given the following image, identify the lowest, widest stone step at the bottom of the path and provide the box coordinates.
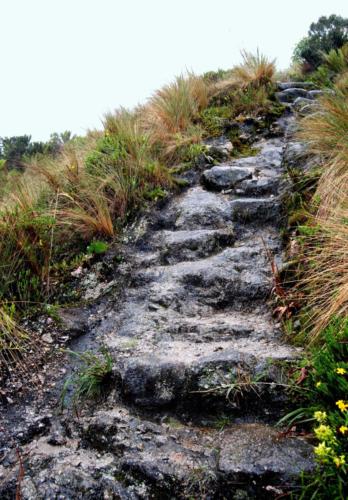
[0,404,314,500]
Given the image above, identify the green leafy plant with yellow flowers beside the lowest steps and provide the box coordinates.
[280,318,348,500]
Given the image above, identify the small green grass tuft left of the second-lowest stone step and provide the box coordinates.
[60,347,112,410]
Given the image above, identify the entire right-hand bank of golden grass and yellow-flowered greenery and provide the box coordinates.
[282,68,348,500]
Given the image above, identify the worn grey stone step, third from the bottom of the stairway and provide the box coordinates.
[104,302,281,348]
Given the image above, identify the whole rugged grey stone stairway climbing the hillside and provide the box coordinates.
[0,84,314,500]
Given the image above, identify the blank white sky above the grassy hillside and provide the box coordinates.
[0,0,348,140]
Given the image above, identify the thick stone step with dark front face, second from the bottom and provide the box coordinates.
[114,338,298,414]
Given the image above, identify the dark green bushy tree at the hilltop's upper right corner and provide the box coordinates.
[293,14,348,71]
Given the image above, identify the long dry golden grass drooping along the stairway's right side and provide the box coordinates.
[299,83,348,341]
